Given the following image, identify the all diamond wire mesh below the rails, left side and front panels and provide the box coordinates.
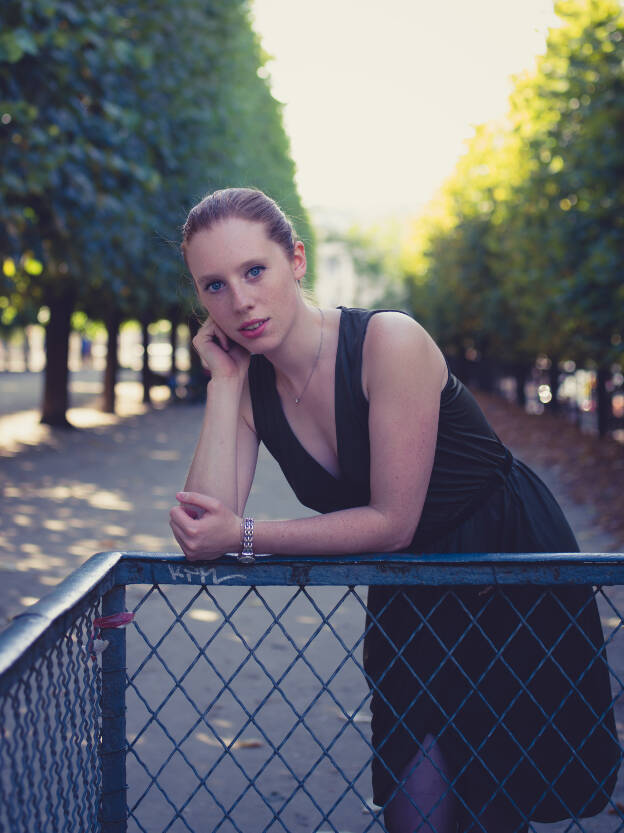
[0,557,624,833]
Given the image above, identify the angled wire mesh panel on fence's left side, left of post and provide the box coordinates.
[0,599,102,833]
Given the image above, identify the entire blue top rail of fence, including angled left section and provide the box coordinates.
[0,552,624,693]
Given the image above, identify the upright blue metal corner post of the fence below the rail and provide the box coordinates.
[100,585,128,833]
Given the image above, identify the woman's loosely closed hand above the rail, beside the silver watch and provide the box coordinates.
[169,492,241,561]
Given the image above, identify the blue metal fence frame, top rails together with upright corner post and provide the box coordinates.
[0,552,624,833]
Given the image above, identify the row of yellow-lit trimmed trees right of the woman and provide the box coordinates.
[403,0,624,434]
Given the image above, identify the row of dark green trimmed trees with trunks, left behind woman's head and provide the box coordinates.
[0,0,310,425]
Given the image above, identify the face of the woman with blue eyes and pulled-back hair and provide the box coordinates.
[186,217,306,353]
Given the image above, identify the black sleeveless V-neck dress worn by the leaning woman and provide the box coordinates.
[249,308,621,822]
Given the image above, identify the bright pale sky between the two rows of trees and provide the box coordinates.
[252,0,558,220]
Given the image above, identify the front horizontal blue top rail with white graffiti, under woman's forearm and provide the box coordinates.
[115,552,624,586]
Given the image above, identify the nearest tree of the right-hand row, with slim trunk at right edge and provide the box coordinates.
[510,0,624,428]
